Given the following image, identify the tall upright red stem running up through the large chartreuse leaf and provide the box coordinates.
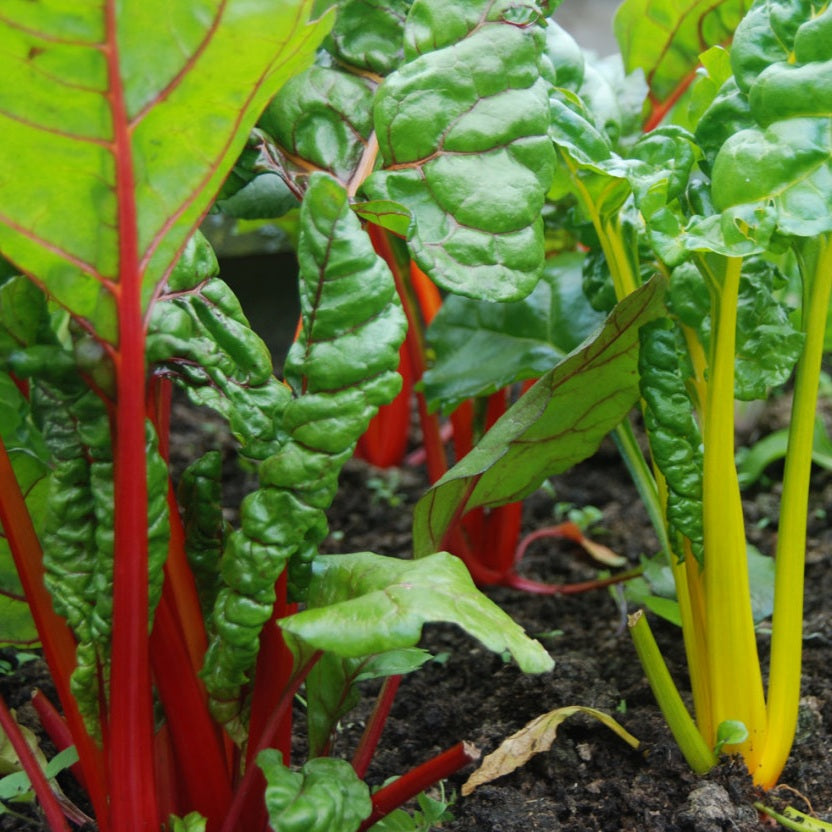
[105,0,160,832]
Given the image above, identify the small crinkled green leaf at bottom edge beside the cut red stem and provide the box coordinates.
[257,748,372,832]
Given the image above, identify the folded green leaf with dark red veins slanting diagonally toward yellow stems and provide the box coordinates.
[413,280,664,556]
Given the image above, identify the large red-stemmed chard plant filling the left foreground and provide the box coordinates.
[0,0,564,832]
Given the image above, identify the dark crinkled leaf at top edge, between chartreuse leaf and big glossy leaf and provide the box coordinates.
[327,0,413,75]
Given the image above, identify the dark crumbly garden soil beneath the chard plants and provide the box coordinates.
[0,392,832,832]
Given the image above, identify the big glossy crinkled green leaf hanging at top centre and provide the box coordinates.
[364,0,554,300]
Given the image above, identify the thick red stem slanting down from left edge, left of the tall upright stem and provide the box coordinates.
[0,439,110,832]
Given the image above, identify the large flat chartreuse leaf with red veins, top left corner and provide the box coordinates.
[0,0,332,342]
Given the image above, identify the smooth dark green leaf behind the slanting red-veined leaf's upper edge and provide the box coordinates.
[422,253,603,412]
